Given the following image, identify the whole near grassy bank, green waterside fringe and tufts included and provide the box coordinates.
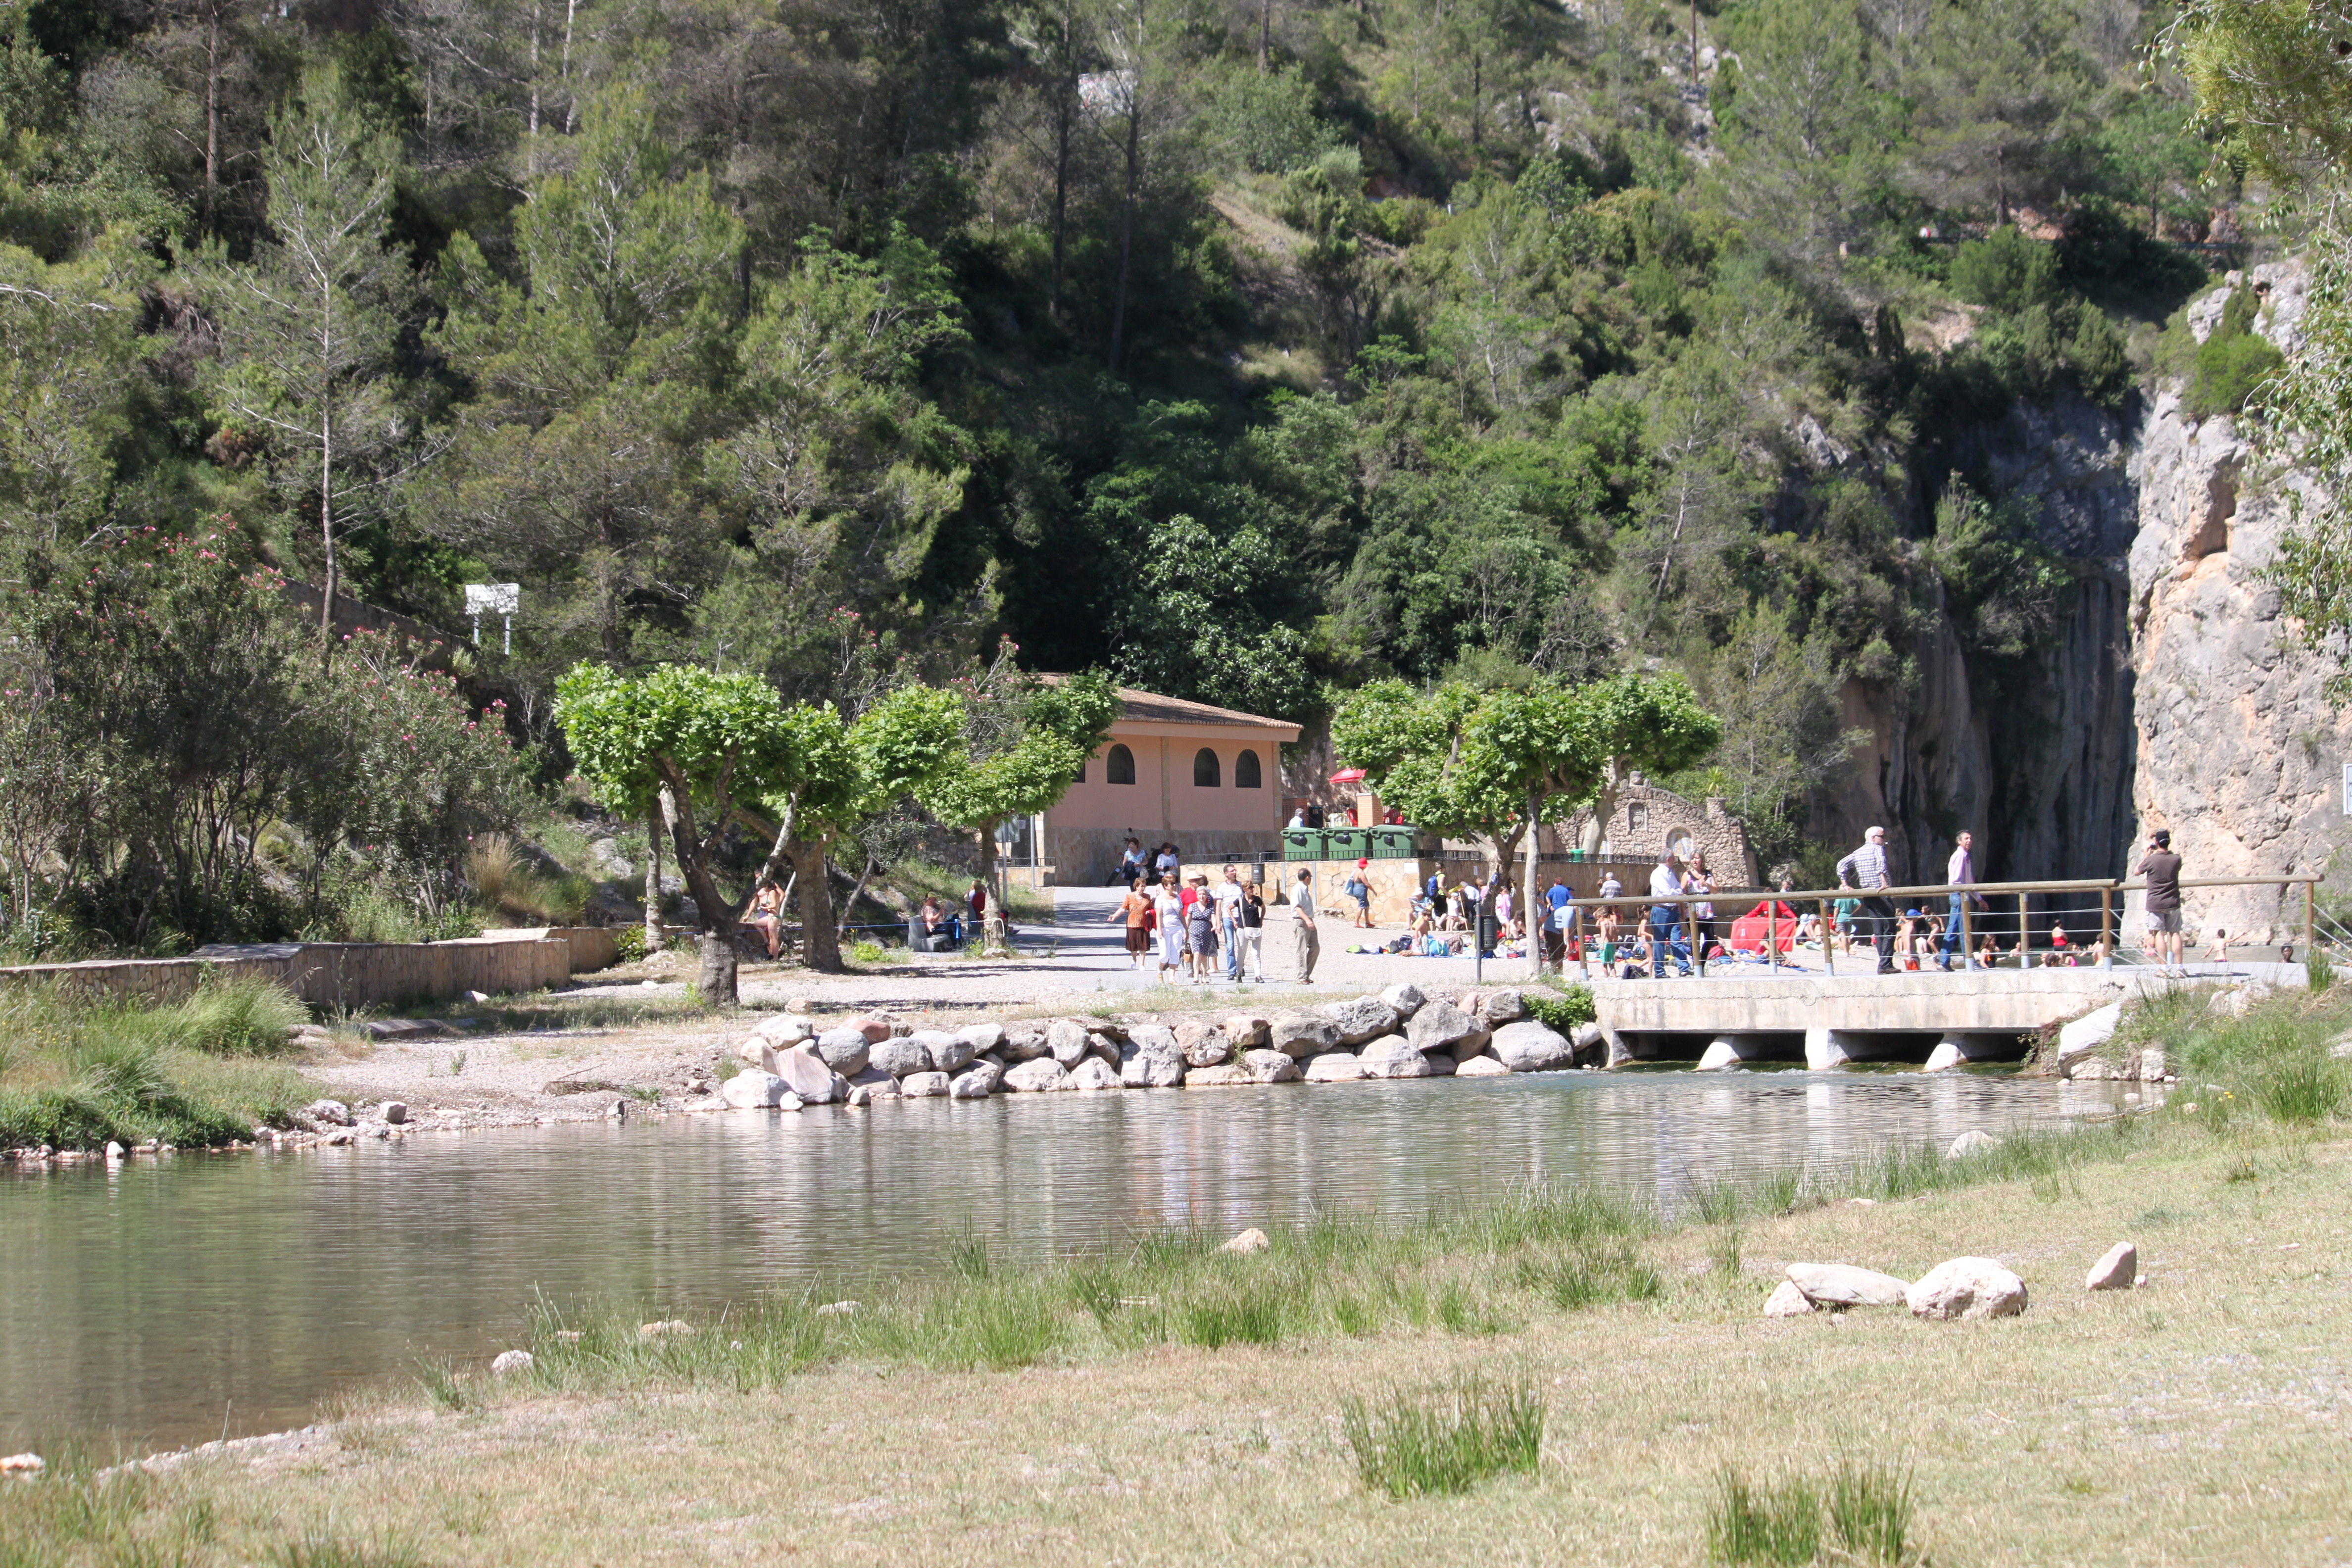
[18,997,2352,1568]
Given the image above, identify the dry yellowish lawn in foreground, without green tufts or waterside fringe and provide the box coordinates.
[18,1114,2352,1568]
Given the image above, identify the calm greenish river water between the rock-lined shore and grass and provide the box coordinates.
[0,1070,2121,1453]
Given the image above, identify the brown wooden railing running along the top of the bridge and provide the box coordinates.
[1536,877,2352,978]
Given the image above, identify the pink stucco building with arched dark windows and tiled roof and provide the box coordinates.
[1030,686,1298,886]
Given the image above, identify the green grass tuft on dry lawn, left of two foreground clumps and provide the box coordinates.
[1341,1373,1545,1502]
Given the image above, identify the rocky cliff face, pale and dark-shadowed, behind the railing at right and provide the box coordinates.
[1816,263,2352,940]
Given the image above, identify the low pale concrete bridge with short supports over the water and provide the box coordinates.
[1592,964,2303,1072]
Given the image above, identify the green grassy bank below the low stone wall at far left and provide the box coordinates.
[0,978,315,1150]
